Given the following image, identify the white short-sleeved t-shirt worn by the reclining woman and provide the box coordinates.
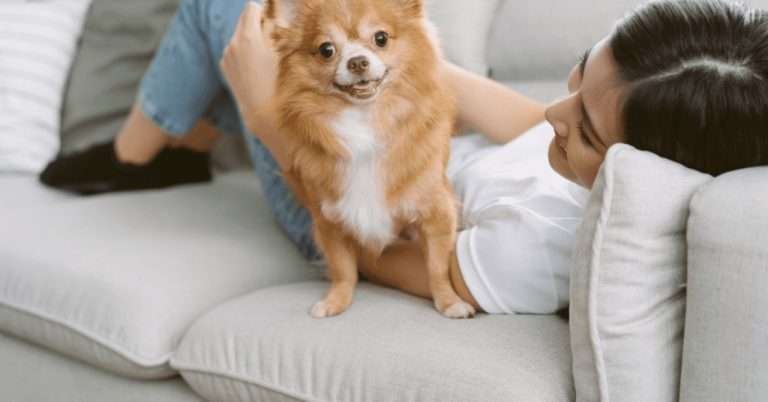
[448,123,589,314]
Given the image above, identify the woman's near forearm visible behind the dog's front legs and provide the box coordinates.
[360,241,482,311]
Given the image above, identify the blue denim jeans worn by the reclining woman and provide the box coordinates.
[138,0,320,260]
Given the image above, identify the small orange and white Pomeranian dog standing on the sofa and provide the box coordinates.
[262,0,475,318]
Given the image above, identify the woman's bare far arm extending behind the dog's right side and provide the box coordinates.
[443,62,545,144]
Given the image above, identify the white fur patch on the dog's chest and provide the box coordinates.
[323,106,393,246]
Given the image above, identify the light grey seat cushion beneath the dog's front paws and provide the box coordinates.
[171,281,573,402]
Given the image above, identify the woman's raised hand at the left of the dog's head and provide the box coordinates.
[221,2,277,133]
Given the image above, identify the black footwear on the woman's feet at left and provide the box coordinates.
[40,141,211,195]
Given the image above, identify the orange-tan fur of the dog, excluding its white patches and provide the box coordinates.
[265,0,471,316]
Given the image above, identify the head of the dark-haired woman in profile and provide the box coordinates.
[547,0,768,187]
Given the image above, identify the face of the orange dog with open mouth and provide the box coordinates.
[264,0,435,104]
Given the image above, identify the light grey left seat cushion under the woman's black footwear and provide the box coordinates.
[0,173,319,378]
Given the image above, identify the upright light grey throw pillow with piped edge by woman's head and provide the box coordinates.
[570,145,711,402]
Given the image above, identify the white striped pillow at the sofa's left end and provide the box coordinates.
[0,0,90,173]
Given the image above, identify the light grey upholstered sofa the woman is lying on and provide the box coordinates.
[0,0,768,402]
